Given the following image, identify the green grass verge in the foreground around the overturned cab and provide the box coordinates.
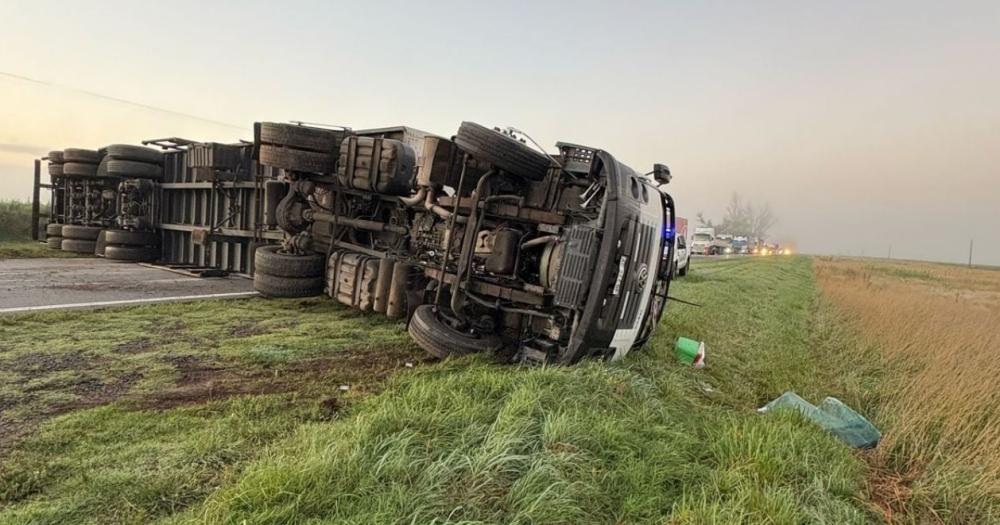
[0,258,875,523]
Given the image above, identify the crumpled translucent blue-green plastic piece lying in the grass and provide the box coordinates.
[757,390,882,448]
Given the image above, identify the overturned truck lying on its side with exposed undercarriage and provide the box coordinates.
[39,122,675,363]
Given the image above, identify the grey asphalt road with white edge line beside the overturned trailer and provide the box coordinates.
[0,258,255,314]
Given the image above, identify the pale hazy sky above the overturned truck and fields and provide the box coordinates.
[0,0,1000,265]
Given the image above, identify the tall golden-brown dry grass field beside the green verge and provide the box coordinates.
[817,259,1000,523]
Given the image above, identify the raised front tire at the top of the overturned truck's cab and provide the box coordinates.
[455,122,552,181]
